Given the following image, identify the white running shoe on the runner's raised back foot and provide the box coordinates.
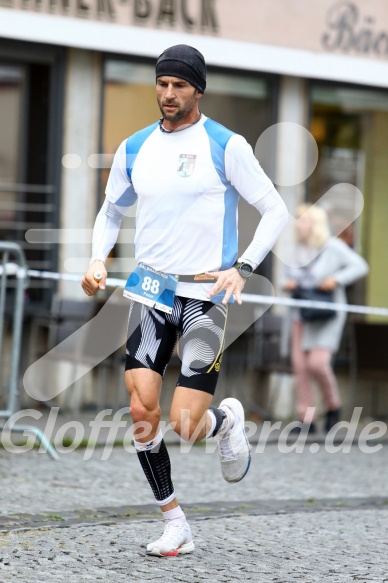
[215,397,251,482]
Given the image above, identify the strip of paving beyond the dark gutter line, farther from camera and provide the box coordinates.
[0,444,388,516]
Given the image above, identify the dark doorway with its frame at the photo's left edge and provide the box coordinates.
[0,41,63,310]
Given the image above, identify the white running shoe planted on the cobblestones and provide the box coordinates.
[146,522,195,557]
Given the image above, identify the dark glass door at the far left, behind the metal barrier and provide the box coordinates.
[0,60,56,302]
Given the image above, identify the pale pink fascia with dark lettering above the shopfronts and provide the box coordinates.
[0,0,388,60]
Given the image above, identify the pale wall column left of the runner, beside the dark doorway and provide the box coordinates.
[58,49,102,299]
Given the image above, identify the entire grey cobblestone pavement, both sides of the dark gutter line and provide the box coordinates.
[0,444,388,583]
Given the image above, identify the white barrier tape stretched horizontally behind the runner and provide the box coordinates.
[27,269,388,317]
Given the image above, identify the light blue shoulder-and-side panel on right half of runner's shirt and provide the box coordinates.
[203,119,239,270]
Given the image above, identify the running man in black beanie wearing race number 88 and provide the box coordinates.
[82,45,288,556]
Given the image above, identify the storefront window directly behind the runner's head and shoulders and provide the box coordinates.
[99,59,275,273]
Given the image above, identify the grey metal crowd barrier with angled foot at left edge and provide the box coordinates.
[0,241,59,460]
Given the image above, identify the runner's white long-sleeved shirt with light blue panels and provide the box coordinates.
[92,115,288,299]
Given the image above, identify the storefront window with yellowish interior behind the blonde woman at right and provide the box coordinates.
[309,83,388,306]
